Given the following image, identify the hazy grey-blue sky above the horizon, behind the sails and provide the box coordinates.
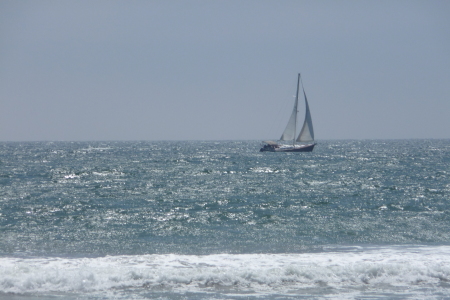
[0,0,450,141]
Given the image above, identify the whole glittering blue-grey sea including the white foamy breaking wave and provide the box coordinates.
[0,140,450,300]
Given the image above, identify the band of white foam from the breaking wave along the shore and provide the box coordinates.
[0,246,450,296]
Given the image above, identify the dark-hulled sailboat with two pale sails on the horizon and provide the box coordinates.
[259,73,316,152]
